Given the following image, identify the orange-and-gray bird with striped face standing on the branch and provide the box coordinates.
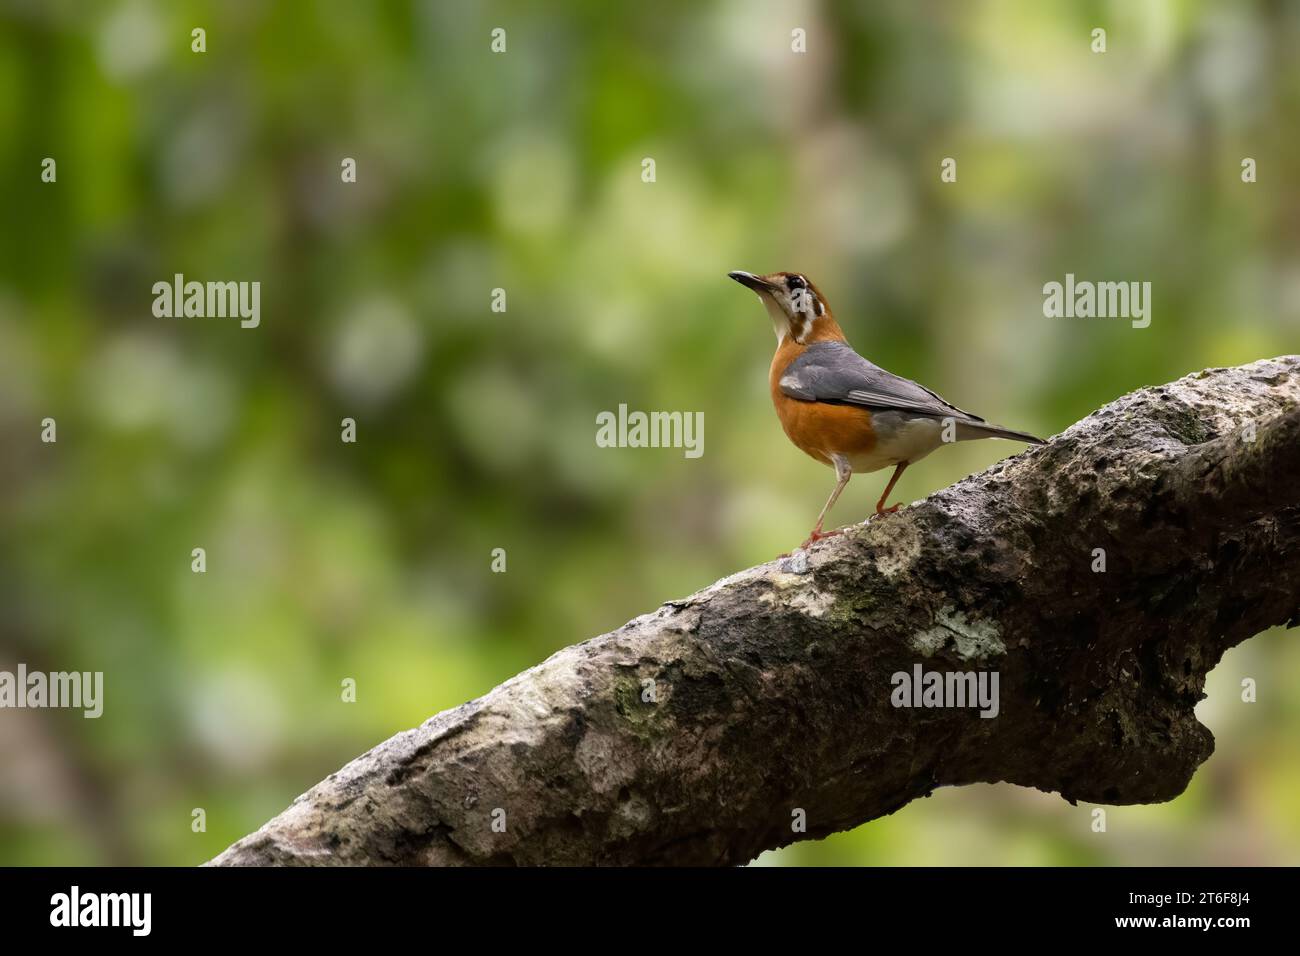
[728,271,1047,548]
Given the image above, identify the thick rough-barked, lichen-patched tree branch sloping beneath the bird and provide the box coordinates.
[213,356,1300,865]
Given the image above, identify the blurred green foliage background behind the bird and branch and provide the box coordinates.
[0,0,1300,865]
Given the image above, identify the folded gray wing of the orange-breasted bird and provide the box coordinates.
[779,342,984,421]
